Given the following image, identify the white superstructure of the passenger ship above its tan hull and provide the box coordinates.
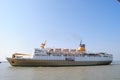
[33,49,113,61]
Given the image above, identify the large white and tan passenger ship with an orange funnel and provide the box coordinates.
[6,41,113,67]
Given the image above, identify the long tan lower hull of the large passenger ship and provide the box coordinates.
[7,58,112,67]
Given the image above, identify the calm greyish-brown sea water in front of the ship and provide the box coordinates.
[0,62,120,80]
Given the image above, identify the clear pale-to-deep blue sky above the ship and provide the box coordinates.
[0,0,120,61]
